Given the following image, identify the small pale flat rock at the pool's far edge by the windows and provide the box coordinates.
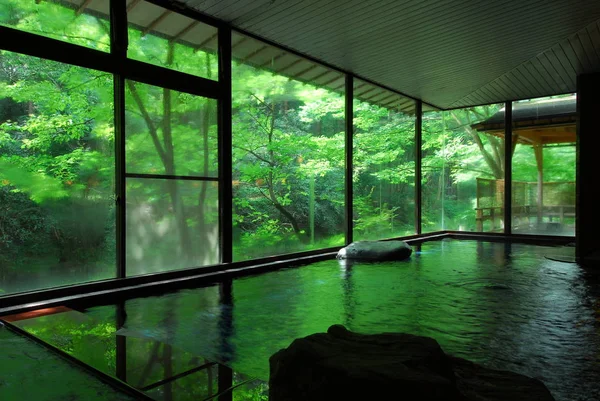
[337,241,412,261]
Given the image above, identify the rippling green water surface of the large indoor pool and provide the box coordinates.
[90,240,600,400]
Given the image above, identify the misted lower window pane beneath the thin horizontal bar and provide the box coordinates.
[126,178,219,275]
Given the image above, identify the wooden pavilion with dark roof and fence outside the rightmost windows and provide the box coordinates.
[472,96,577,231]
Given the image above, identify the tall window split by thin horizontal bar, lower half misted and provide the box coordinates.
[125,81,219,275]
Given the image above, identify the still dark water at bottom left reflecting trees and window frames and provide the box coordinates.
[2,304,266,401]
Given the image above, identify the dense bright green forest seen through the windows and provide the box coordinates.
[0,0,574,292]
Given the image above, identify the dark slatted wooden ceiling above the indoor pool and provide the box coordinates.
[180,0,600,108]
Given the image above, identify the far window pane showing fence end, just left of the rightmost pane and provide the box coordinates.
[422,104,504,232]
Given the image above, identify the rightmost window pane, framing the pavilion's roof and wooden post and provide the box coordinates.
[512,95,577,236]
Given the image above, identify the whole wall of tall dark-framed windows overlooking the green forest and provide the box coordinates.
[0,0,576,296]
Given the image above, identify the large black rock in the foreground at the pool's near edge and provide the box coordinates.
[269,325,554,401]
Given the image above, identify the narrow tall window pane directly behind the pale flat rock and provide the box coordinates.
[353,80,415,240]
